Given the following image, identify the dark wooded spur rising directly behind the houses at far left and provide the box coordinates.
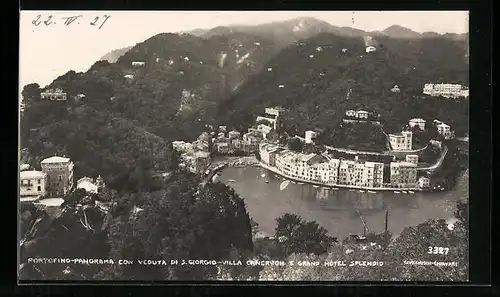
[21,101,176,191]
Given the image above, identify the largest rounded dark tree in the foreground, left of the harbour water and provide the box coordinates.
[109,172,253,280]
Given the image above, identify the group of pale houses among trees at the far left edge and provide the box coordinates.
[19,156,105,201]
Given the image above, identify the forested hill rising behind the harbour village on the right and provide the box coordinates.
[218,34,469,138]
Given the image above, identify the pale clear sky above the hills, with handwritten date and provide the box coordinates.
[19,11,468,91]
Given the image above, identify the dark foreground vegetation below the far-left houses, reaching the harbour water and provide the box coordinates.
[21,172,253,280]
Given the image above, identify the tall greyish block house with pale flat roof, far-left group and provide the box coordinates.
[41,156,74,196]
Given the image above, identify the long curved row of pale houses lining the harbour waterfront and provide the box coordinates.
[259,142,430,189]
